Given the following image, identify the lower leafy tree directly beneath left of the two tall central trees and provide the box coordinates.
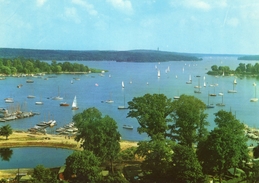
[136,139,174,183]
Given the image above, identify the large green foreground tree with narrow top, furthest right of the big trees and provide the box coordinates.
[197,110,248,180]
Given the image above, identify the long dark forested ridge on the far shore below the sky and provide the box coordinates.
[0,48,202,62]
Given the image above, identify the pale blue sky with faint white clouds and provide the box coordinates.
[0,0,259,54]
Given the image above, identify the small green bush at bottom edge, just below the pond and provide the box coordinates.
[32,165,58,183]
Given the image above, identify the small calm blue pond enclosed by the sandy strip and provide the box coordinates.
[0,147,73,169]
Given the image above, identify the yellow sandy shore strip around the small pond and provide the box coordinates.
[0,131,137,179]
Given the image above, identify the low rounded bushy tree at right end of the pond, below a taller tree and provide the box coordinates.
[64,150,101,183]
